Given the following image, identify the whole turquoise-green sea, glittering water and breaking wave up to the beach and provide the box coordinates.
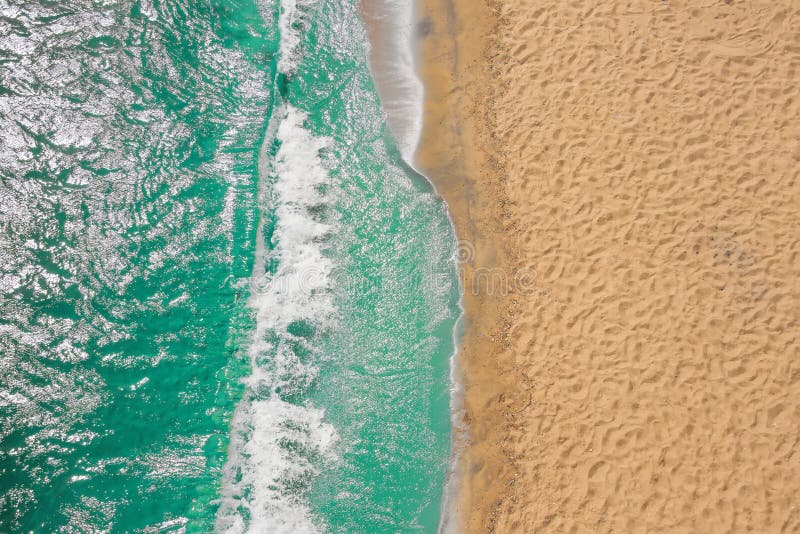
[0,0,458,532]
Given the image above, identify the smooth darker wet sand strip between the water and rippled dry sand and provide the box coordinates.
[416,0,516,532]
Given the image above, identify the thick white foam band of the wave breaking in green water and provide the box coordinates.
[216,0,338,534]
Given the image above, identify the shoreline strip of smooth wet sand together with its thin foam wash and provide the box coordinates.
[360,0,513,533]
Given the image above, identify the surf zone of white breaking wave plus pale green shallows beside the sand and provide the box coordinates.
[217,1,460,532]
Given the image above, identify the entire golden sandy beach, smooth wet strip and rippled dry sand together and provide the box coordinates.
[418,0,800,532]
